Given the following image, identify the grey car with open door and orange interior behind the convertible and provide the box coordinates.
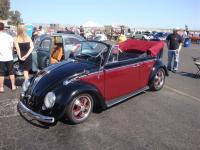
[14,33,85,76]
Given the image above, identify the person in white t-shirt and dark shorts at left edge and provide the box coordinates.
[0,22,17,93]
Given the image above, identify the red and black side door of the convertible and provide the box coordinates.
[104,49,140,101]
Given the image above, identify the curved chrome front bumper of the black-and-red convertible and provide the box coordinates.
[17,101,55,123]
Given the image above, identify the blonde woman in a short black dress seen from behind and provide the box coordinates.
[14,25,33,80]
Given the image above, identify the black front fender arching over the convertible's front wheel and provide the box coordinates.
[52,80,106,119]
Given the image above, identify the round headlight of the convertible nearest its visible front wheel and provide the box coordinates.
[44,92,56,108]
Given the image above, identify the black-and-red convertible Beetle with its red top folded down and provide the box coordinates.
[18,40,168,124]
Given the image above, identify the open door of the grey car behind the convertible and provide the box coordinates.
[36,37,52,69]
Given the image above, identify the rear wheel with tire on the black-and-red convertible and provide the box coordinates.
[150,68,165,91]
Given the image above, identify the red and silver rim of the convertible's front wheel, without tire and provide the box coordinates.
[72,96,91,120]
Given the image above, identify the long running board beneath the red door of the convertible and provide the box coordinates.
[106,86,149,107]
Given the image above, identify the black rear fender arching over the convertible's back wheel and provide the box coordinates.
[149,59,169,83]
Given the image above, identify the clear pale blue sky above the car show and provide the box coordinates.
[11,0,200,29]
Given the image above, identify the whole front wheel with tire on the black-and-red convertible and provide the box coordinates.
[66,93,94,124]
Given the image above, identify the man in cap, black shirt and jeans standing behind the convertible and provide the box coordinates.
[166,28,183,73]
